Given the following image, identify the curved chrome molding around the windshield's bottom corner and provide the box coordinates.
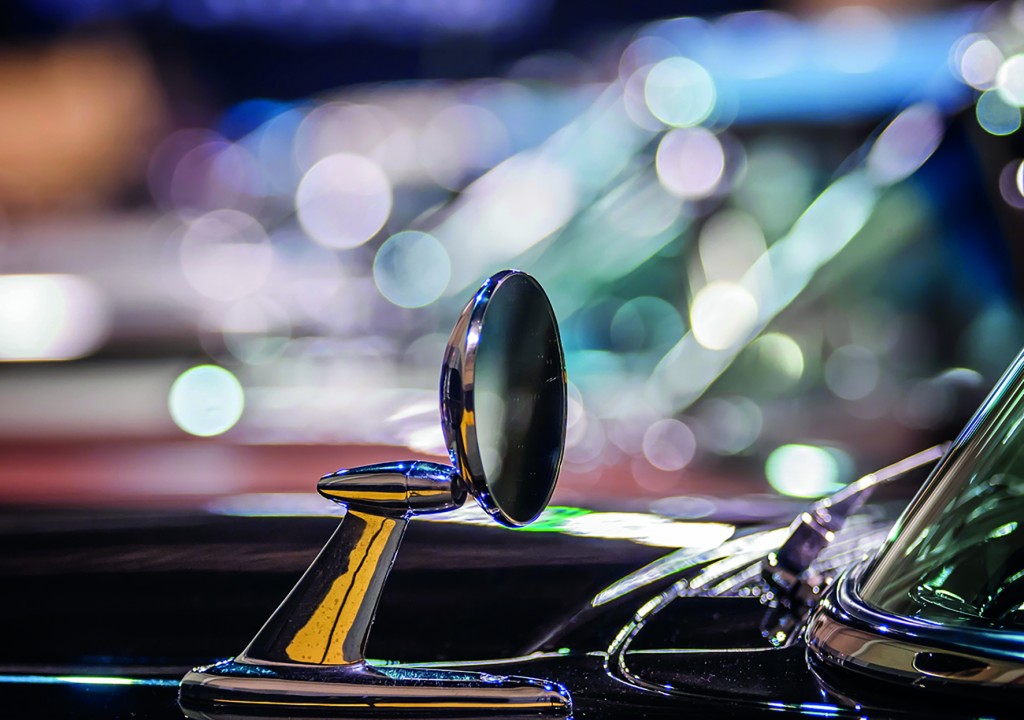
[806,567,1024,688]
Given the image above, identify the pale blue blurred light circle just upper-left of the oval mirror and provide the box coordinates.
[374,230,452,307]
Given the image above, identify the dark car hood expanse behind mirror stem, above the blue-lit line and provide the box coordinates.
[0,509,668,672]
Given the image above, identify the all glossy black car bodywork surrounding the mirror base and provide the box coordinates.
[0,510,1013,718]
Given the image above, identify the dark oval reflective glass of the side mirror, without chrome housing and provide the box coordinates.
[473,273,566,524]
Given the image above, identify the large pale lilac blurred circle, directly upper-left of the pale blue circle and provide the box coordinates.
[295,153,392,249]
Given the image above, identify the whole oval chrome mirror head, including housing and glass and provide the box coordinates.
[441,270,566,526]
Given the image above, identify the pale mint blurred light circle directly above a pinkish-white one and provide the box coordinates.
[644,57,716,127]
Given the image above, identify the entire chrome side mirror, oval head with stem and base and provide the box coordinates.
[180,270,571,717]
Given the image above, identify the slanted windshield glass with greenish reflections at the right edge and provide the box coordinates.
[860,353,1024,630]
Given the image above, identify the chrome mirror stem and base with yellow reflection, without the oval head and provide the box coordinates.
[179,461,571,718]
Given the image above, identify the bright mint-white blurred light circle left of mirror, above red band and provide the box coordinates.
[167,365,246,437]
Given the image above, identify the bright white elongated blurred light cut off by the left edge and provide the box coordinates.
[0,274,112,361]
